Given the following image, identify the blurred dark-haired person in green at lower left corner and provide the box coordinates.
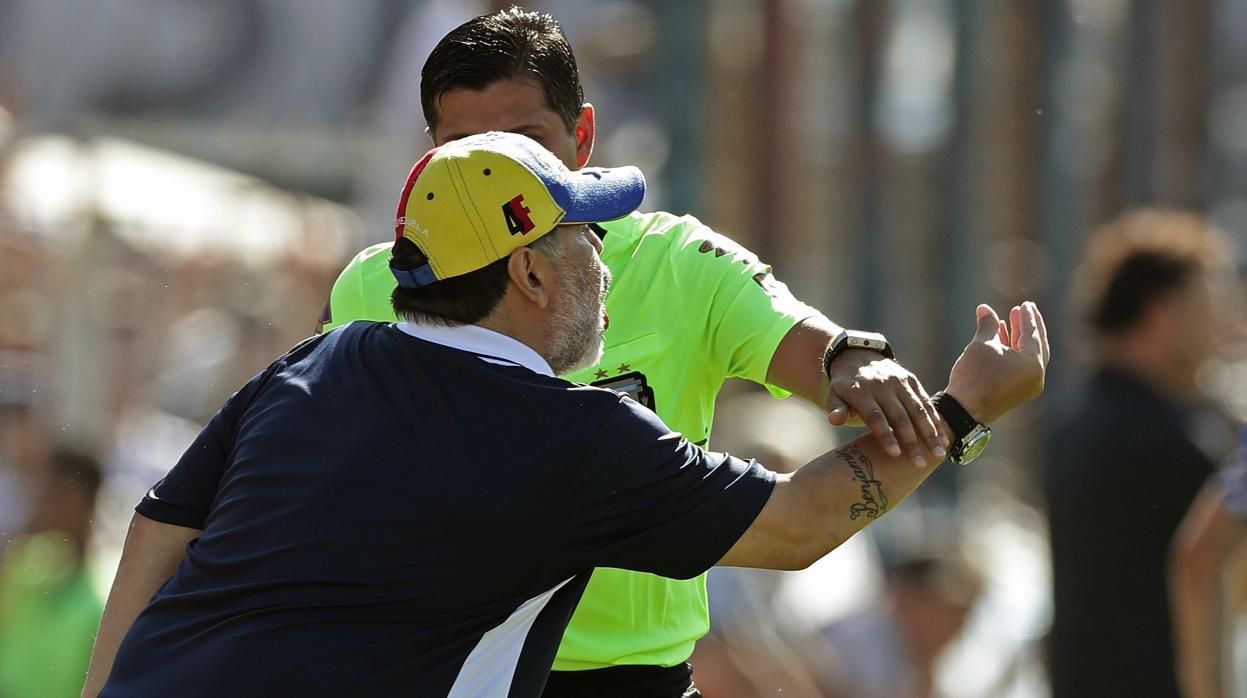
[0,450,104,698]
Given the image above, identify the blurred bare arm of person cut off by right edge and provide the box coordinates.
[1170,426,1247,698]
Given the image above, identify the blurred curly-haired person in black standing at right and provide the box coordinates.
[1044,209,1230,698]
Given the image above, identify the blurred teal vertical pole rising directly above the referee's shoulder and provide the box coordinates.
[653,0,708,213]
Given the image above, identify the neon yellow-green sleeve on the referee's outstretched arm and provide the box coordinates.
[676,226,818,396]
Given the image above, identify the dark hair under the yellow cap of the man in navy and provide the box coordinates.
[390,233,561,327]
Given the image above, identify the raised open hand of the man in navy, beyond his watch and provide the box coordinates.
[946,300,1050,424]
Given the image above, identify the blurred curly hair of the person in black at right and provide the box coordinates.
[1076,208,1223,338]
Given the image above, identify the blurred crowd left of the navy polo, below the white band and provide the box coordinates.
[0,172,349,697]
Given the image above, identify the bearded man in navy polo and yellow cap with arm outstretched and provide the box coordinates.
[85,133,1047,696]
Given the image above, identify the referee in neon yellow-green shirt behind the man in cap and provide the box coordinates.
[322,7,950,698]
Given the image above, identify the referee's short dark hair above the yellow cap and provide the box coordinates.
[420,6,585,133]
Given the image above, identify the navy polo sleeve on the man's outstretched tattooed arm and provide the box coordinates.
[566,398,774,578]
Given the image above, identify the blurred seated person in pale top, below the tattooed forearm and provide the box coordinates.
[804,547,984,698]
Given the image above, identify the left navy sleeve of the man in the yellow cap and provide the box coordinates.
[135,360,281,528]
